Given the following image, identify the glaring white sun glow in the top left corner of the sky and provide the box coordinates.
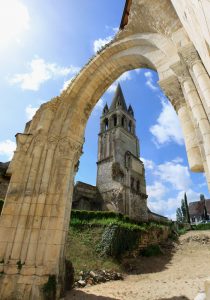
[0,0,30,48]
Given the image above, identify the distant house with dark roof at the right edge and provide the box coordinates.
[189,199,210,223]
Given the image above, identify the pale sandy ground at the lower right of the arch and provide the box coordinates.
[65,231,210,300]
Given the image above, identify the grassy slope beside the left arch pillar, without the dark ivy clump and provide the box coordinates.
[67,211,171,277]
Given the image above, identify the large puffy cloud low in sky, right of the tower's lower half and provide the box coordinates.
[141,157,199,219]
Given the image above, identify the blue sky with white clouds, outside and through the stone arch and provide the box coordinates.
[0,0,209,217]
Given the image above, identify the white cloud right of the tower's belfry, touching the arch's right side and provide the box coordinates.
[150,98,183,146]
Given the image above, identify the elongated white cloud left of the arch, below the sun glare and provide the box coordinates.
[10,58,80,91]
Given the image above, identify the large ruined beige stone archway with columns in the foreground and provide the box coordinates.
[0,0,210,299]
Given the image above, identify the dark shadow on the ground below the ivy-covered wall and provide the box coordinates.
[122,241,180,274]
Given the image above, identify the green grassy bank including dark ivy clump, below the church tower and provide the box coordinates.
[67,210,171,278]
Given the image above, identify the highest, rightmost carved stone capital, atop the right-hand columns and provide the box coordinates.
[178,43,201,69]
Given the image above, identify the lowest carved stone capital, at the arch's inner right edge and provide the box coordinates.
[159,75,186,112]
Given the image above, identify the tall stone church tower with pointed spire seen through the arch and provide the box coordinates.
[97,84,148,220]
